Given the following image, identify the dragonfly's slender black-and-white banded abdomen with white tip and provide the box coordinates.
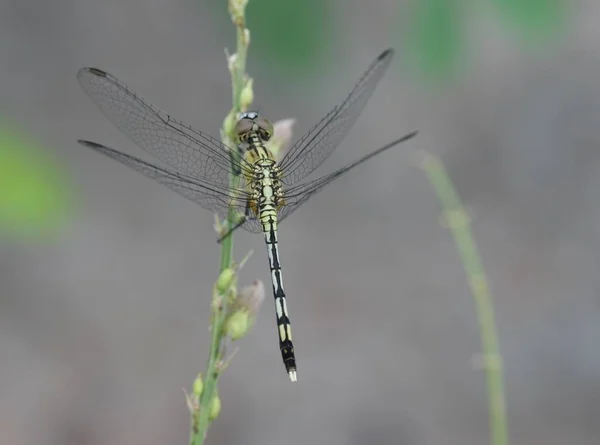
[265,228,297,382]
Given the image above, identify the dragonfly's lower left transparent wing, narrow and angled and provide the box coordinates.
[78,140,262,233]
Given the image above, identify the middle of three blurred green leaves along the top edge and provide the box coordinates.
[406,0,463,79]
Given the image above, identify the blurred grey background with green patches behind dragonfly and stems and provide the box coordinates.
[0,0,600,445]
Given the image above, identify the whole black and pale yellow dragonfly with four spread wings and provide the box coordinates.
[77,49,417,382]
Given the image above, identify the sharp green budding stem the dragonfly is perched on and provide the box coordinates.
[190,0,250,445]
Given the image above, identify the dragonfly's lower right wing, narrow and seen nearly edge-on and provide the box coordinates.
[279,131,417,221]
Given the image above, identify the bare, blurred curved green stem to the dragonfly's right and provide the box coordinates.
[421,153,508,445]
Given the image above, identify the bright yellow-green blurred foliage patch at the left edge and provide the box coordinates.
[0,124,71,238]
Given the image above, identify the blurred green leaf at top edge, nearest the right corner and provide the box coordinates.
[492,0,566,37]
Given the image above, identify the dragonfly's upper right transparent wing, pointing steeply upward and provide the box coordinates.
[280,49,394,185]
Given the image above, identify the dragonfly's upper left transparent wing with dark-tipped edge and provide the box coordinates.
[77,68,249,186]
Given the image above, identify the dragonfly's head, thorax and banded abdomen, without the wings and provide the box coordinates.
[235,112,297,382]
